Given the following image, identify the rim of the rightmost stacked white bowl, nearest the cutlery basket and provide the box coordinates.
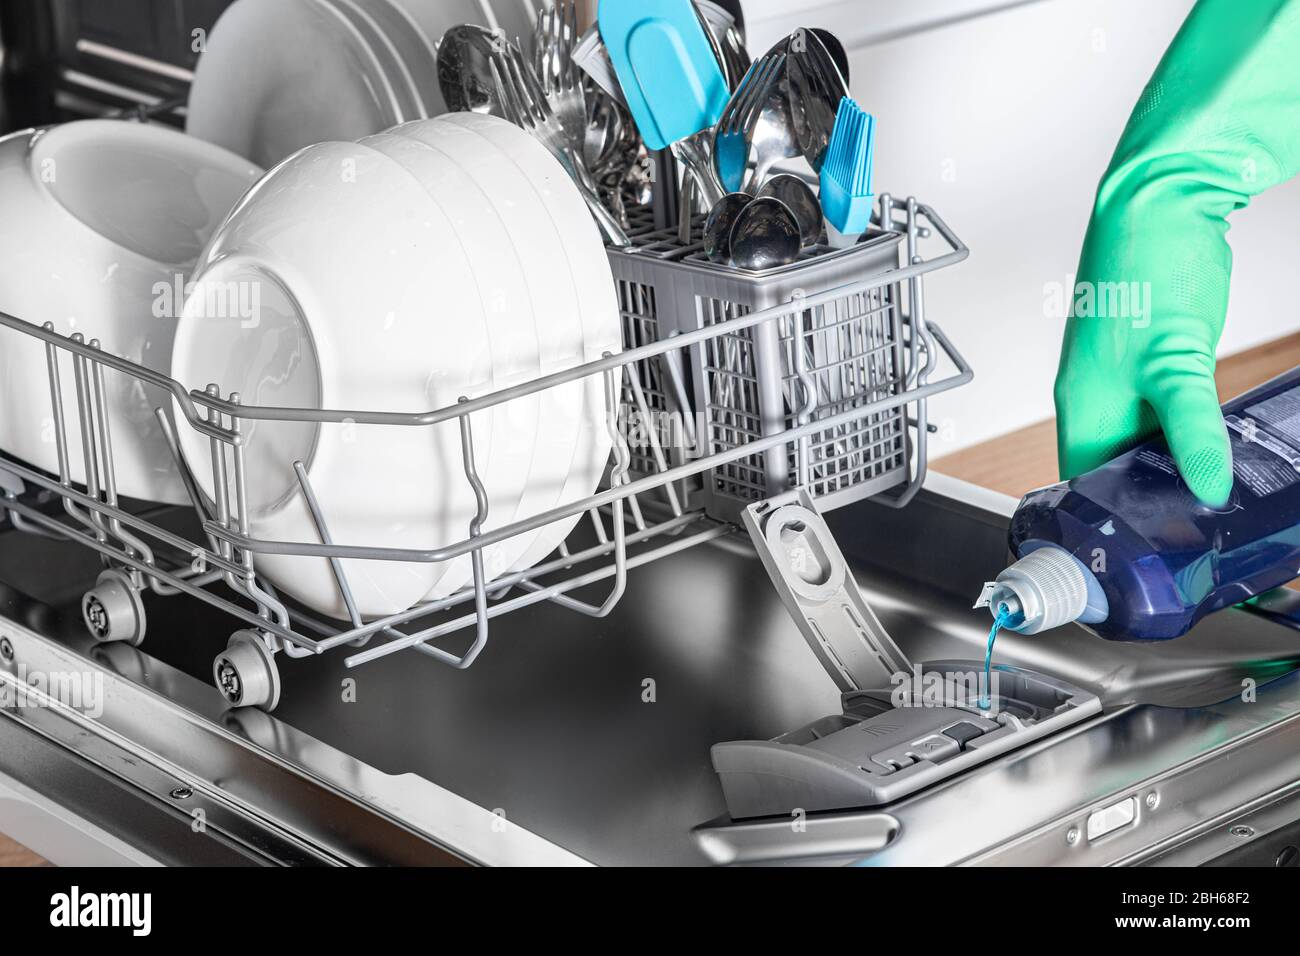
[445,113,623,570]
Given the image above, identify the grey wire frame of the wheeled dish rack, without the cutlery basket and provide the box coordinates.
[0,195,971,710]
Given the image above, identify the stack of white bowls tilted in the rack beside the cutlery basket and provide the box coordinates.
[173,113,620,618]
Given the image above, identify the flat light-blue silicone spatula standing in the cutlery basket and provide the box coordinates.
[597,0,731,204]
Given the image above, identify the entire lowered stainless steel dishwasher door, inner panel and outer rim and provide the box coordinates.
[0,476,1300,865]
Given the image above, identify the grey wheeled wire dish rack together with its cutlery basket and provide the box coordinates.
[0,194,971,710]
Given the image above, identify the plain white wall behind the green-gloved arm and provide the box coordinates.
[780,0,1300,455]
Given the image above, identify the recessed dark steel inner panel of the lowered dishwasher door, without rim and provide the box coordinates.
[0,481,1300,864]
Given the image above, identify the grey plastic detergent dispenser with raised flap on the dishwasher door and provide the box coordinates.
[712,489,1101,821]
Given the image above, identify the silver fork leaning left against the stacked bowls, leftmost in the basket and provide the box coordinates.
[489,44,632,246]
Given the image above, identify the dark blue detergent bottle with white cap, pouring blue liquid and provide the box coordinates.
[976,368,1300,640]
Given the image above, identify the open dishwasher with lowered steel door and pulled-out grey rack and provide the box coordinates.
[0,164,1300,865]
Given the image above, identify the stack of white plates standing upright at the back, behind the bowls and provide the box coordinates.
[186,0,536,166]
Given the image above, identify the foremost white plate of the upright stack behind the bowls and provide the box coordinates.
[186,0,393,166]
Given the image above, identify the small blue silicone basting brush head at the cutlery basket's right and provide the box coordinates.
[820,96,876,248]
